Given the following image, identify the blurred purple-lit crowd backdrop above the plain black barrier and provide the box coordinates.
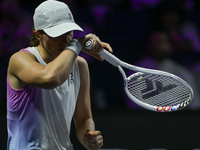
[0,0,200,112]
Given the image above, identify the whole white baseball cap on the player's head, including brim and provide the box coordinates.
[33,0,83,37]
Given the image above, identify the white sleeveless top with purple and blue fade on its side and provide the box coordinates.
[7,47,80,150]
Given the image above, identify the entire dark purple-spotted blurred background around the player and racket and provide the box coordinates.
[0,0,200,150]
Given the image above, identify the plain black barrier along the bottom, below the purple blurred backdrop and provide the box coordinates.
[0,109,200,150]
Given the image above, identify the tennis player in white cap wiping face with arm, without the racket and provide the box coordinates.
[7,0,112,150]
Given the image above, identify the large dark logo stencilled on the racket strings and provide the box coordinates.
[141,79,178,99]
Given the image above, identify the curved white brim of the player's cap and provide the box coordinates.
[43,22,83,37]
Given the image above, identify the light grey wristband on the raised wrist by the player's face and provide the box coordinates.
[65,39,82,56]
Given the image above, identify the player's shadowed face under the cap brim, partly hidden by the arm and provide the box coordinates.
[40,31,73,57]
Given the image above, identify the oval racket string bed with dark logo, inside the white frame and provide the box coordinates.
[127,74,191,106]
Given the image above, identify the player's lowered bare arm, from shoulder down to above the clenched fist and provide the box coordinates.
[74,57,92,126]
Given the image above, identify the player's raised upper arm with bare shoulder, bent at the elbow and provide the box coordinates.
[8,51,55,89]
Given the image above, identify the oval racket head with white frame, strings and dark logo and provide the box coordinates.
[125,72,194,112]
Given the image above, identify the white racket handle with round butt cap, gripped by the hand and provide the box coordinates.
[85,39,121,67]
